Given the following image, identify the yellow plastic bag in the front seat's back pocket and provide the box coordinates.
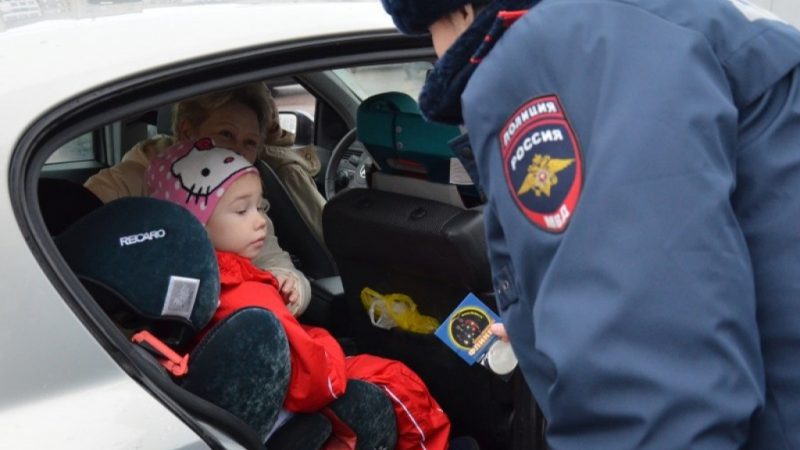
[361,287,439,334]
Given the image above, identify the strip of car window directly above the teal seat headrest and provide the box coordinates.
[333,61,433,100]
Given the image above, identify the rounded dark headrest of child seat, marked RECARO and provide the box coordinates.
[55,198,220,345]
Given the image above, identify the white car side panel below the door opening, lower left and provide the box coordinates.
[0,210,206,450]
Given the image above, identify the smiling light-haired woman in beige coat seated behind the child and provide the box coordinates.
[84,83,311,316]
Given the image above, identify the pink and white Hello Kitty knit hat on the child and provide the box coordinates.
[144,138,258,225]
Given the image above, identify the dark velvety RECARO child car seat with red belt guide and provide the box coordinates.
[55,198,396,450]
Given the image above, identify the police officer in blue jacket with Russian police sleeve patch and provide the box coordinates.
[382,0,800,450]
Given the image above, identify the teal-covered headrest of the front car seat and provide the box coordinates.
[356,92,461,183]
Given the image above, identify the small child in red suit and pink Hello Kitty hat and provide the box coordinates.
[145,138,450,450]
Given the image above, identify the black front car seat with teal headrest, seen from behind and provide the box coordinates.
[323,93,515,449]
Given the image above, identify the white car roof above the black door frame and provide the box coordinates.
[0,1,393,165]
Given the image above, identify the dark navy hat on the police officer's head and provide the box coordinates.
[381,0,491,34]
